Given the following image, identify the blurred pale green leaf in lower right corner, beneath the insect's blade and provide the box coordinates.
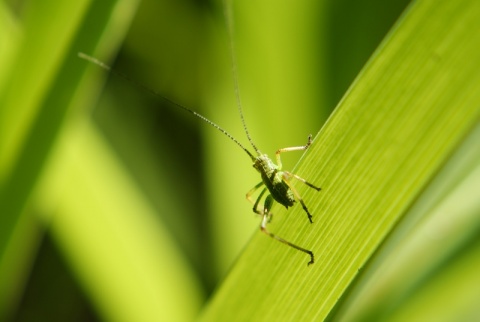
[337,126,480,321]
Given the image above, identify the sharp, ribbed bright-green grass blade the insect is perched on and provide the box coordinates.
[198,0,480,320]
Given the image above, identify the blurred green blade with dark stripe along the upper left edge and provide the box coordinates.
[0,0,139,316]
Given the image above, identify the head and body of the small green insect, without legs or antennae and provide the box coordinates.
[253,154,295,208]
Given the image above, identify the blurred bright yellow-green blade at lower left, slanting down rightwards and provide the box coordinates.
[35,121,202,321]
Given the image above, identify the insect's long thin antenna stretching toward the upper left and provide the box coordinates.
[78,52,255,161]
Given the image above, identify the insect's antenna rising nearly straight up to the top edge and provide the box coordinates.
[224,0,261,154]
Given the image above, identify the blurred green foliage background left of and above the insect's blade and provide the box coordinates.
[0,0,408,321]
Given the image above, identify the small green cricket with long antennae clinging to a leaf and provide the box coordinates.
[78,4,321,266]
